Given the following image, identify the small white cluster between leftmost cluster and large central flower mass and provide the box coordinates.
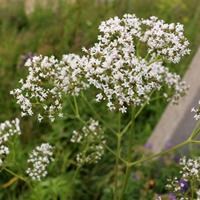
[56,54,88,96]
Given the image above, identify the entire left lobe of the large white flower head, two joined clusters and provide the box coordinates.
[11,54,88,121]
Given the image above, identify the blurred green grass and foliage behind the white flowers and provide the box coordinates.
[0,0,200,200]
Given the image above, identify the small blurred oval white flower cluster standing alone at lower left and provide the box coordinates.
[26,143,53,181]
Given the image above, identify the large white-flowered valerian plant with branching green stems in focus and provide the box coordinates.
[2,14,198,200]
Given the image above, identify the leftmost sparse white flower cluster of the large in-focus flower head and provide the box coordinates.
[11,55,62,121]
